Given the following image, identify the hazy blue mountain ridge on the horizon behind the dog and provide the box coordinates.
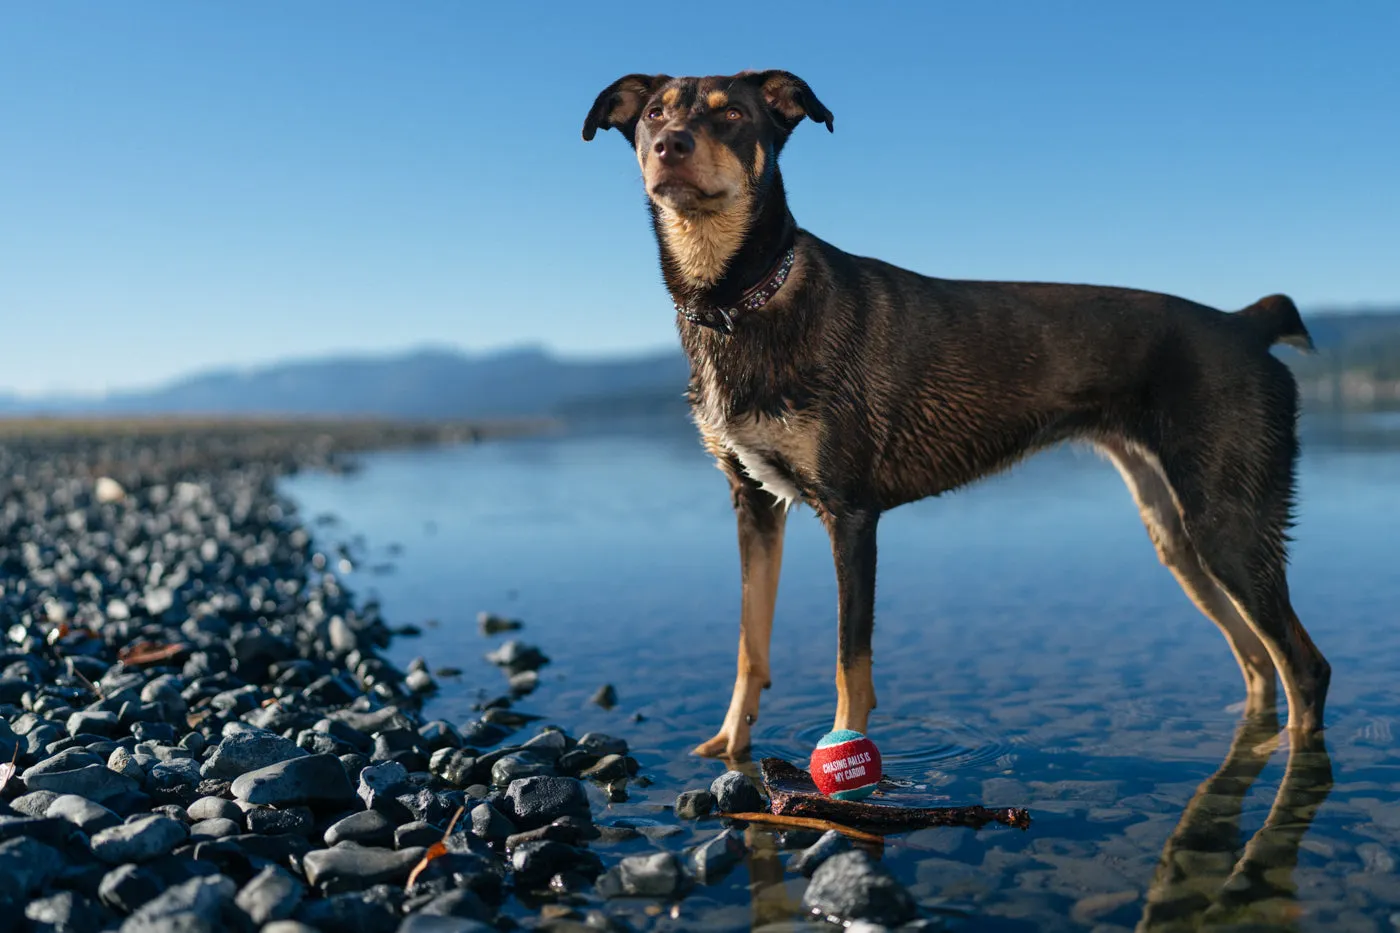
[0,308,1400,420]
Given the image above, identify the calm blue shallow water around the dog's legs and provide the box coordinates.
[286,416,1400,930]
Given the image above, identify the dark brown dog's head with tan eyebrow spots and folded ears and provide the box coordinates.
[584,71,832,216]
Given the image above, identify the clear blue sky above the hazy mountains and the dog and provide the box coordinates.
[0,0,1400,394]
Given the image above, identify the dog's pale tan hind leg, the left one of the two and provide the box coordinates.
[1099,440,1277,716]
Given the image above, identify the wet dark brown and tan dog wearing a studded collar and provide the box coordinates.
[582,70,1331,758]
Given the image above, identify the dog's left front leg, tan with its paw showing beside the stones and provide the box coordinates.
[696,471,787,758]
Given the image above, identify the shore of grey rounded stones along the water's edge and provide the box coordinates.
[0,423,934,933]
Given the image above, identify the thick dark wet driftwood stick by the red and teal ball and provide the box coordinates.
[759,758,1030,835]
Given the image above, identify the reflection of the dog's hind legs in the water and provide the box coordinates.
[1137,716,1331,933]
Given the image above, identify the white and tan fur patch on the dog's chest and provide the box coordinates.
[692,353,819,506]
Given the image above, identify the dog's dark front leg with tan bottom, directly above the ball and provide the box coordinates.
[823,509,879,733]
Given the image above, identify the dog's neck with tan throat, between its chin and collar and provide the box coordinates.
[651,171,797,318]
